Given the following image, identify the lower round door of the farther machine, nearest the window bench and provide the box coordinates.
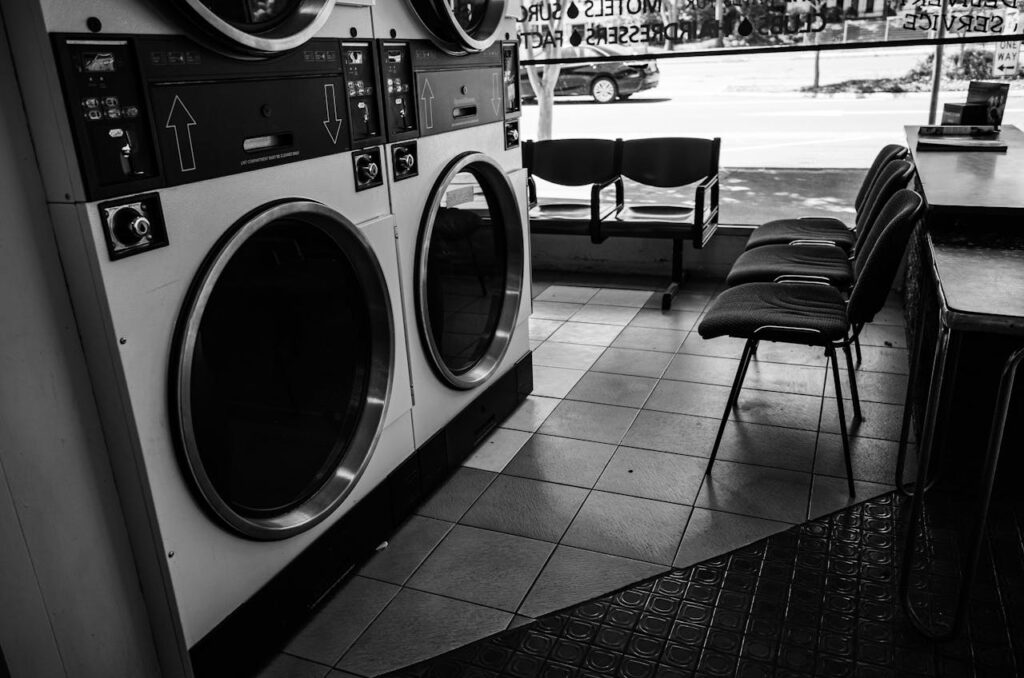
[416,153,524,389]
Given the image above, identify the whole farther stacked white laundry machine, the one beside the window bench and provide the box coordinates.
[373,0,532,468]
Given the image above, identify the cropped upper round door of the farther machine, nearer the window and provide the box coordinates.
[408,0,507,56]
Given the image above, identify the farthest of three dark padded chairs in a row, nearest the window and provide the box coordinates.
[745,143,908,252]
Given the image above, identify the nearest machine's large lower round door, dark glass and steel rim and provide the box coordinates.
[170,201,394,540]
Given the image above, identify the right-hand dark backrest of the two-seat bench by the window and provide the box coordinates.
[622,136,722,188]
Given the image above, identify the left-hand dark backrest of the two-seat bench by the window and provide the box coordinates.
[522,139,622,186]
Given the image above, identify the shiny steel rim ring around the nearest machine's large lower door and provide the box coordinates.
[170,200,395,541]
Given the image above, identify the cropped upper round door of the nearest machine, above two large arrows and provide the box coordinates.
[163,0,333,58]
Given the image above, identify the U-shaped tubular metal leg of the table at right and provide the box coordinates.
[900,346,1024,640]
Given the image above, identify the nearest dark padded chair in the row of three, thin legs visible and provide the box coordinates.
[697,188,924,497]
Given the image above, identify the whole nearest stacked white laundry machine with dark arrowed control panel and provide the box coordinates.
[0,0,419,676]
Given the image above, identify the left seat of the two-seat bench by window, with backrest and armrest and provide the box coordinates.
[522,139,623,235]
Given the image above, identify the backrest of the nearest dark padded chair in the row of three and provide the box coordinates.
[847,188,925,325]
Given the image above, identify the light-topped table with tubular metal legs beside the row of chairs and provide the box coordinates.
[897,127,1024,640]
